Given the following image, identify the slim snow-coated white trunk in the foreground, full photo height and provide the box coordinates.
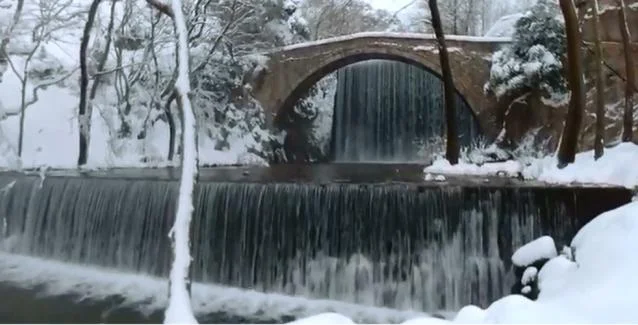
[164,0,197,324]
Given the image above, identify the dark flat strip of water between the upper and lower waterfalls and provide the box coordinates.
[8,163,632,188]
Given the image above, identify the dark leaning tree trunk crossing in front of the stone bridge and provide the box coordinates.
[428,0,459,165]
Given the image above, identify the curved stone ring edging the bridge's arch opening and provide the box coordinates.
[275,51,484,132]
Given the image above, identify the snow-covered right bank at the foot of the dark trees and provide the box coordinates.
[424,143,638,188]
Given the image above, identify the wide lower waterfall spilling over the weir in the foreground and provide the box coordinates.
[0,174,628,311]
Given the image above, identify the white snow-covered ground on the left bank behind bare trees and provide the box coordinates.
[0,57,263,169]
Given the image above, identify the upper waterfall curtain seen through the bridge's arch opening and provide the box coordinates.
[332,60,479,162]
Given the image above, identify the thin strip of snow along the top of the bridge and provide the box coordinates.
[278,32,511,53]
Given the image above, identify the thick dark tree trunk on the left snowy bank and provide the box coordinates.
[78,0,100,167]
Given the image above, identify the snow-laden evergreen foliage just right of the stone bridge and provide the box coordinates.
[485,0,568,103]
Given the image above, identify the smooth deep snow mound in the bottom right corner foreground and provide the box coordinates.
[292,196,638,324]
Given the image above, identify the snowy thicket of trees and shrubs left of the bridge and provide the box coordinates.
[0,0,308,168]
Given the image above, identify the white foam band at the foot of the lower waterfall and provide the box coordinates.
[0,253,424,323]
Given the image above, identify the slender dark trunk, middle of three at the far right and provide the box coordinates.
[592,0,605,159]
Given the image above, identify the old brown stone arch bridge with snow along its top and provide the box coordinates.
[248,33,509,136]
